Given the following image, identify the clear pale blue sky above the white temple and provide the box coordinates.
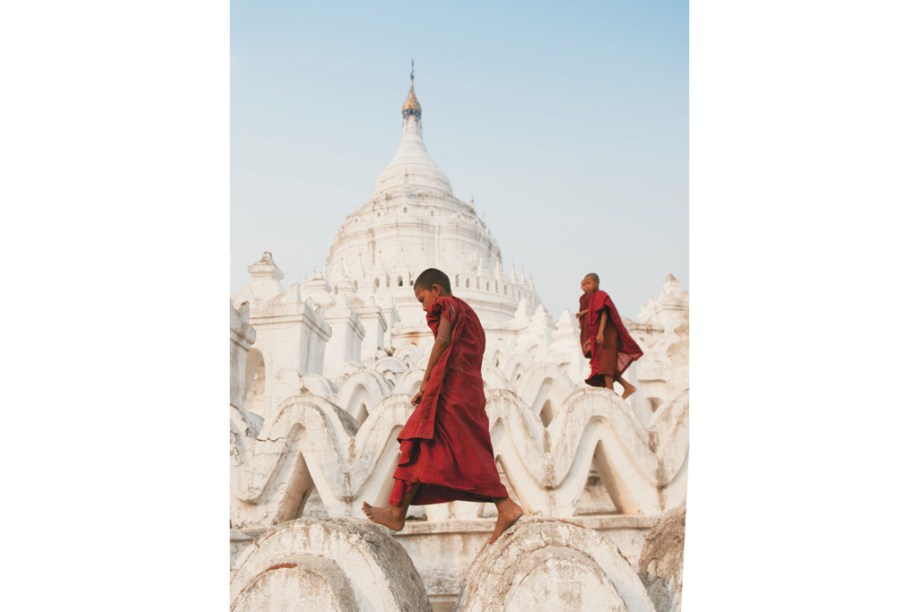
[230,0,690,319]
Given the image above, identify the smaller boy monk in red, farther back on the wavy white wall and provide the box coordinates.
[575,272,644,399]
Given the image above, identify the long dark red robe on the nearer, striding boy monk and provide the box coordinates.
[389,296,507,506]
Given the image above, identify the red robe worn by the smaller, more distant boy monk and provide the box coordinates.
[580,289,644,387]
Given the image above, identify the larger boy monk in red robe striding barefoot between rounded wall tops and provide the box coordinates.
[363,268,523,544]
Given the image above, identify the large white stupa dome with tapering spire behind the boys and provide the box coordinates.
[326,80,540,324]
